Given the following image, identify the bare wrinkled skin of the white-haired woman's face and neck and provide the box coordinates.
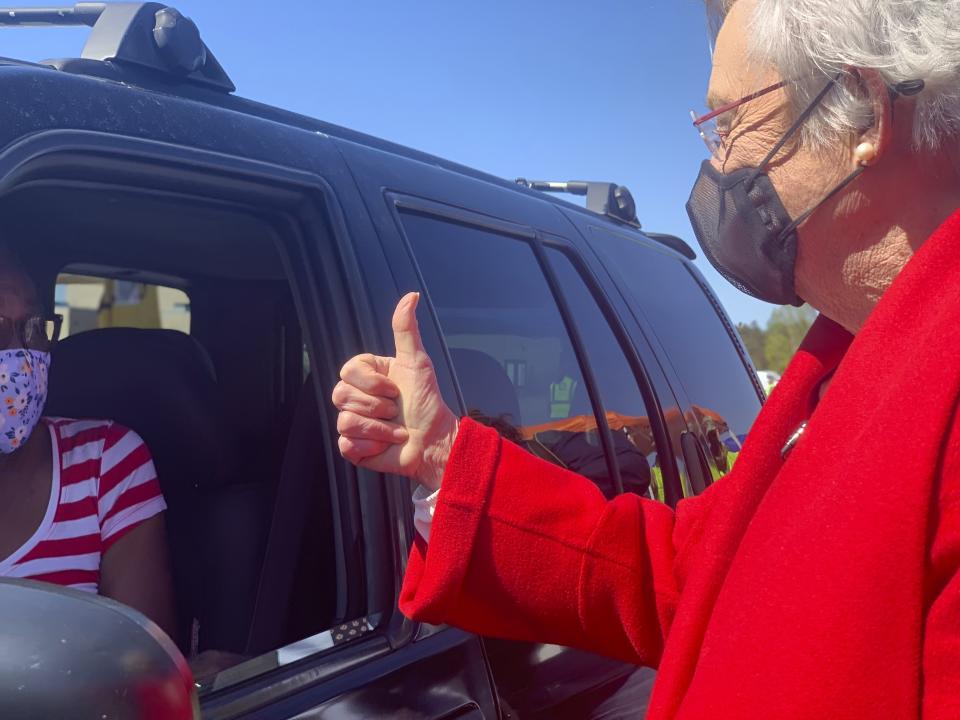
[707,0,960,333]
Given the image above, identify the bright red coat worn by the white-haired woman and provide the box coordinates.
[400,207,960,720]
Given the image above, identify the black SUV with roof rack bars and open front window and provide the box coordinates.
[0,3,762,719]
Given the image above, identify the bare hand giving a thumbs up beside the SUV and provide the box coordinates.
[333,293,458,490]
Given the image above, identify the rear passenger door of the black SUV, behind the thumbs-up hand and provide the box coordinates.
[345,138,676,718]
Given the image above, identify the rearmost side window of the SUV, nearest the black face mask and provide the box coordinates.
[591,228,760,476]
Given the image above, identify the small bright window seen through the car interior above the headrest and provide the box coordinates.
[55,273,190,337]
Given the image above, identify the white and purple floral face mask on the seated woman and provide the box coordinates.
[0,348,50,455]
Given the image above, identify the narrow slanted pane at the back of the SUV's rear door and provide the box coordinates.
[547,248,664,502]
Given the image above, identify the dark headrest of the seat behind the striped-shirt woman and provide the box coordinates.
[46,328,237,492]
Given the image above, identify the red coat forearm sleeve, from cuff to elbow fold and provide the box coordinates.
[400,419,696,666]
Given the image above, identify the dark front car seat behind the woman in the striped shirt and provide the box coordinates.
[47,328,265,652]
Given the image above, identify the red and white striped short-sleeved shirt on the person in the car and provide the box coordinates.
[0,418,167,592]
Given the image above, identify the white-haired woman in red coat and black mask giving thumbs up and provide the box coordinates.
[334,0,960,720]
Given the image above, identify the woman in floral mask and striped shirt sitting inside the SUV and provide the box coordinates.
[0,248,174,633]
